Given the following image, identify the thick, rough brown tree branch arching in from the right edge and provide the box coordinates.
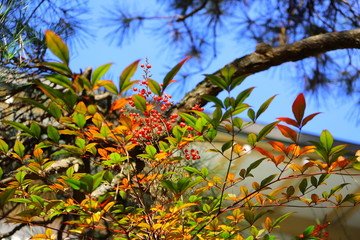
[170,29,360,112]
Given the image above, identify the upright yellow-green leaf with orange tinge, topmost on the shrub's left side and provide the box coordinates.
[45,30,69,65]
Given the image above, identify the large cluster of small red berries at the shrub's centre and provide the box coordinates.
[114,62,200,164]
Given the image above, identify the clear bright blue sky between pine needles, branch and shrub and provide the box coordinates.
[66,0,360,144]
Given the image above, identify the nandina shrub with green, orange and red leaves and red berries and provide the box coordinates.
[0,31,359,240]
